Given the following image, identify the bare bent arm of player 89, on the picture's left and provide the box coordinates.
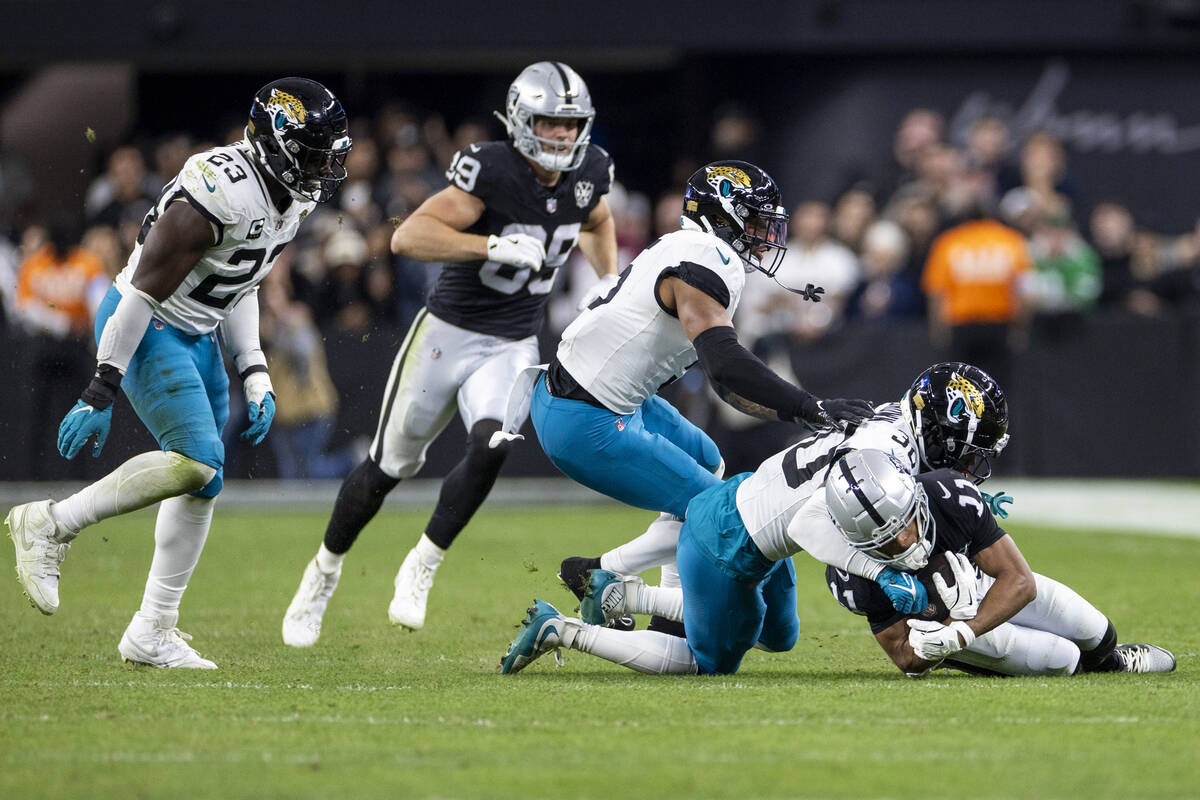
[391,186,488,261]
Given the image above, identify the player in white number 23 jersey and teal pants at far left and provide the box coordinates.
[6,78,350,669]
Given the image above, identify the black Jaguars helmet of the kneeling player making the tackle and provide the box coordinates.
[900,361,1008,483]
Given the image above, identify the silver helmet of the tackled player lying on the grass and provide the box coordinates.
[826,450,937,571]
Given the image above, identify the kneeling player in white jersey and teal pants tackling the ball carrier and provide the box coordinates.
[500,362,1008,674]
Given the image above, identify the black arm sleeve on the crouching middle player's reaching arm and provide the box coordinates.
[692,325,817,422]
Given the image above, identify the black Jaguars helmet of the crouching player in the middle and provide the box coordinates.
[680,161,787,276]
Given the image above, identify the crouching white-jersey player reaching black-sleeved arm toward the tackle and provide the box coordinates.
[530,161,872,624]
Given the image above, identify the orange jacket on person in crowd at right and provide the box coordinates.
[920,219,1033,325]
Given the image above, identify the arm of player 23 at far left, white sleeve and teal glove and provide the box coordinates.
[58,201,216,458]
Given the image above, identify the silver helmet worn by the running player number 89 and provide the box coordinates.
[494,61,596,173]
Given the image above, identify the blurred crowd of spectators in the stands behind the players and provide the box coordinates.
[0,99,1200,477]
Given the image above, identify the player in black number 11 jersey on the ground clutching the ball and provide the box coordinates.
[824,450,1175,678]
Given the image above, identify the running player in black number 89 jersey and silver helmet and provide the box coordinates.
[283,61,617,646]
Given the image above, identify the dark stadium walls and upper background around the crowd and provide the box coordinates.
[0,0,1200,480]
